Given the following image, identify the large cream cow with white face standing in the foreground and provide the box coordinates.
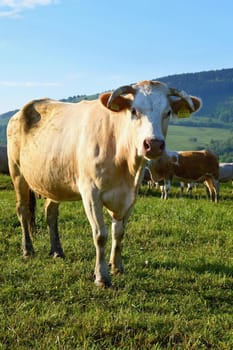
[7,81,201,287]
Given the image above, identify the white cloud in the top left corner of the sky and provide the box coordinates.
[0,0,57,17]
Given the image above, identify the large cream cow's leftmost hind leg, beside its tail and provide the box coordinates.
[12,174,35,257]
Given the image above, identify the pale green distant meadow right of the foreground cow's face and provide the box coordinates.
[167,125,232,151]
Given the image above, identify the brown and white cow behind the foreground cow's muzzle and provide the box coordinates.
[148,150,219,202]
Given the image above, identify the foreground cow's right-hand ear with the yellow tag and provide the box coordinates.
[171,96,202,118]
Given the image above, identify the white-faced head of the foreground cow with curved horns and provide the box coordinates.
[104,81,201,159]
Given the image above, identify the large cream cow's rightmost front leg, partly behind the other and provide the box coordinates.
[109,219,125,275]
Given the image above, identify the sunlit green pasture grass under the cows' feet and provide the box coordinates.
[0,175,233,350]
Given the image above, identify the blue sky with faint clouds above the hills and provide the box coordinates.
[0,0,233,114]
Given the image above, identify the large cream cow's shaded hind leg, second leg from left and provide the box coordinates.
[45,199,65,258]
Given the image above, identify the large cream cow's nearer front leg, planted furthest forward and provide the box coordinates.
[82,189,111,287]
